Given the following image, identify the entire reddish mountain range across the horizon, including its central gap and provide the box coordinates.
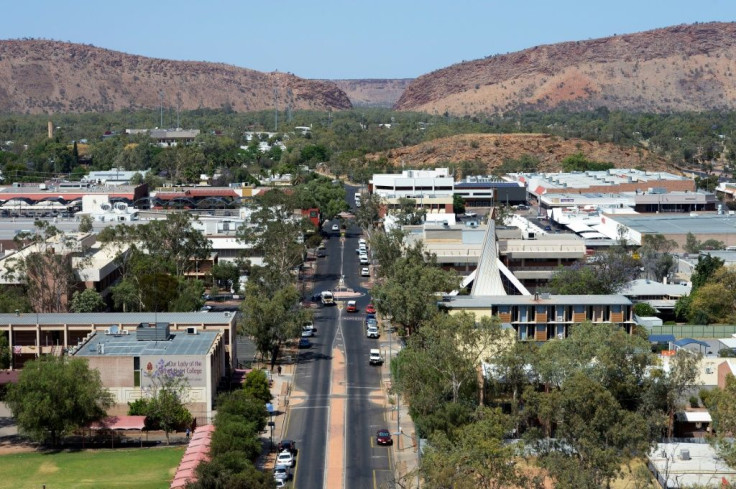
[0,22,736,116]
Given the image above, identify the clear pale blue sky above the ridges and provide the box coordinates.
[5,0,736,79]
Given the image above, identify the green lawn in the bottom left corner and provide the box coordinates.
[0,447,184,489]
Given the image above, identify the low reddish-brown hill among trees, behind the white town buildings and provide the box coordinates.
[368,134,672,173]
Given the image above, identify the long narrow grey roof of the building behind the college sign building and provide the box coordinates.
[0,311,235,326]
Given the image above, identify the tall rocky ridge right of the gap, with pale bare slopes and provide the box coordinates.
[396,23,736,115]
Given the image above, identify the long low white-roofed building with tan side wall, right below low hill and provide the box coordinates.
[506,168,695,200]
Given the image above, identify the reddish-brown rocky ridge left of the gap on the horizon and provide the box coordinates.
[0,40,351,113]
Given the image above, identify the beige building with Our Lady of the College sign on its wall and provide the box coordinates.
[70,322,227,424]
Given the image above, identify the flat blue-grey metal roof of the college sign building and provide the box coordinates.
[74,331,220,357]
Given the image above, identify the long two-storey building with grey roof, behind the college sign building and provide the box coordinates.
[0,312,238,369]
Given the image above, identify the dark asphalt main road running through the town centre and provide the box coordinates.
[285,184,393,489]
